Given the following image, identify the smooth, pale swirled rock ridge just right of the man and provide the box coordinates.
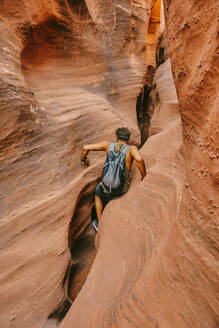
[61,30,185,328]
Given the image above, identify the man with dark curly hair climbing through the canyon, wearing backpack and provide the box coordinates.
[81,128,146,231]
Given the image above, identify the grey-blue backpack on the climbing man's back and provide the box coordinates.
[102,142,128,192]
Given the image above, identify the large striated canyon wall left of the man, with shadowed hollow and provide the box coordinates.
[0,0,150,328]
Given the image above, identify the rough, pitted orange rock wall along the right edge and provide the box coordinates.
[165,1,219,327]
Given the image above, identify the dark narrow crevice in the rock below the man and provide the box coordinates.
[48,178,99,327]
